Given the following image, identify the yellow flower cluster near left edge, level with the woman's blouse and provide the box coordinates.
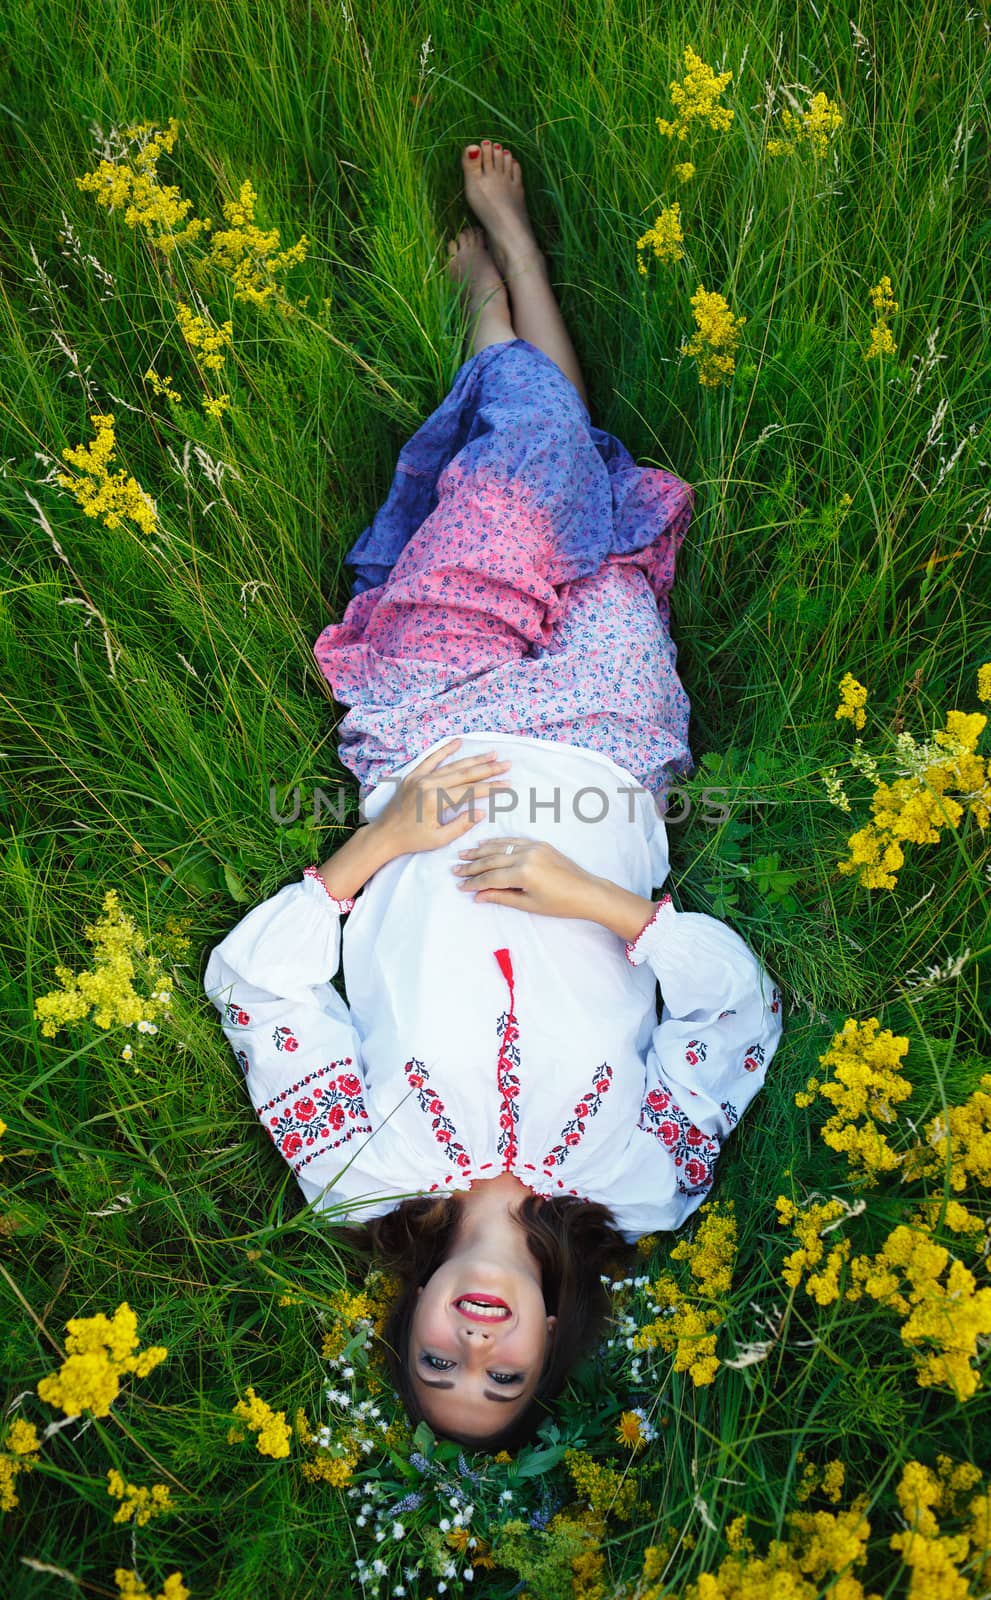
[35,890,189,1038]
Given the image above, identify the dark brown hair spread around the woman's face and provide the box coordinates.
[351,1194,632,1451]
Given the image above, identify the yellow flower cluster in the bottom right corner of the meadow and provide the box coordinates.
[889,1456,991,1600]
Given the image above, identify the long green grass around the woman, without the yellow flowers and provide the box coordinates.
[0,0,991,1600]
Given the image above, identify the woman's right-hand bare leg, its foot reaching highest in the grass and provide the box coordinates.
[461,139,588,408]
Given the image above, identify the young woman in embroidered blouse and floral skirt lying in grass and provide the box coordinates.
[205,139,781,1450]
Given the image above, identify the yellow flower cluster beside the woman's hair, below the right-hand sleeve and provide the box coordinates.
[632,1206,736,1386]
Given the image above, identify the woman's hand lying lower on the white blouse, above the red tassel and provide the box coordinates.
[451,838,602,922]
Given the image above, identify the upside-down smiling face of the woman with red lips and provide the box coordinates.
[408,1256,557,1438]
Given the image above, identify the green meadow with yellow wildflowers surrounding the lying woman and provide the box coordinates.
[0,0,991,1600]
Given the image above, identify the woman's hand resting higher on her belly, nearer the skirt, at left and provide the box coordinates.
[370,739,512,856]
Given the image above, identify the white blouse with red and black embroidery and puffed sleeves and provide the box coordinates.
[205,733,781,1238]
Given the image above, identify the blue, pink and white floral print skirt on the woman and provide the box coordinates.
[314,339,693,794]
